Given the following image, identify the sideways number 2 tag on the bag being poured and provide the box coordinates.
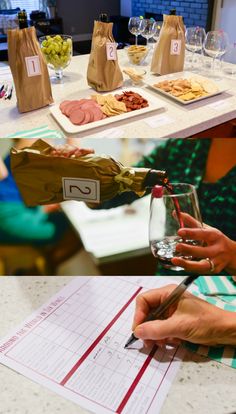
[62,177,100,203]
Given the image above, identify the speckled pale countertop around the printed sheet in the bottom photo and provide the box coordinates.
[0,276,236,414]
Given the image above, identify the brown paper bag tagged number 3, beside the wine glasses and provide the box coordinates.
[151,15,185,75]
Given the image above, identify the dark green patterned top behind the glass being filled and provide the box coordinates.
[102,139,236,274]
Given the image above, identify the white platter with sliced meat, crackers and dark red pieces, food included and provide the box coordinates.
[50,88,163,134]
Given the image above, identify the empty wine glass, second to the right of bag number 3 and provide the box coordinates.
[204,30,229,72]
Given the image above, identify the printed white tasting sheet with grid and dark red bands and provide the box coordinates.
[3,278,181,414]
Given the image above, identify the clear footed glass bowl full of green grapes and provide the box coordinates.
[39,35,72,79]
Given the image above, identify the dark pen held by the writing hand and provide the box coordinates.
[125,275,199,348]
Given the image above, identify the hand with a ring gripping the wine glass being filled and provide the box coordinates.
[172,225,236,274]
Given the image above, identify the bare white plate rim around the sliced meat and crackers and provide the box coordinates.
[50,88,164,134]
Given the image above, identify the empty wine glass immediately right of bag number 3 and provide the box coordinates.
[185,26,206,67]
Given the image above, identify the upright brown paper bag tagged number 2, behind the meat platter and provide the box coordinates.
[87,21,123,92]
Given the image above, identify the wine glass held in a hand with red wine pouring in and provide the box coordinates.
[149,183,202,271]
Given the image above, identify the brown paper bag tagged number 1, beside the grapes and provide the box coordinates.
[8,27,53,112]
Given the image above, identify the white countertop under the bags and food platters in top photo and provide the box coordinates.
[0,50,236,138]
